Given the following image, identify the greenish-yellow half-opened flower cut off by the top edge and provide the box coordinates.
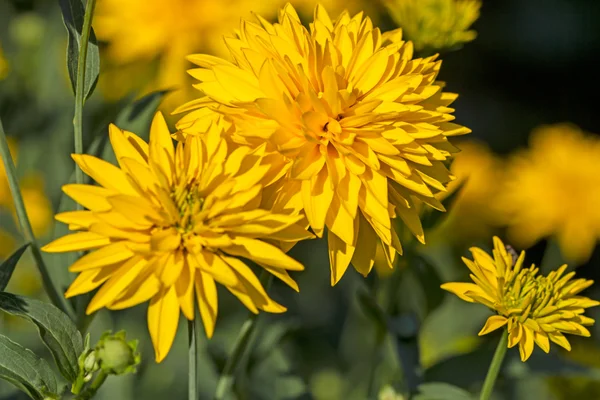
[384,0,481,51]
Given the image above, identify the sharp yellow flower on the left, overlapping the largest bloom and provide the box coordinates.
[43,113,310,362]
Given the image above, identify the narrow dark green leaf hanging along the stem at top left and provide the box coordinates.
[58,0,100,99]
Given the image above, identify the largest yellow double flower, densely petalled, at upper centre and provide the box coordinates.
[178,4,470,284]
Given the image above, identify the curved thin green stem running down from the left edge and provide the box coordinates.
[0,120,73,317]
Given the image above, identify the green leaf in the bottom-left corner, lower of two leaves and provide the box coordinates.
[0,335,60,400]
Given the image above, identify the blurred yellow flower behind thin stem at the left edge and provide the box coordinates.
[0,139,52,238]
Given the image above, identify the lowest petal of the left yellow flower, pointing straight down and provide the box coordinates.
[148,286,179,363]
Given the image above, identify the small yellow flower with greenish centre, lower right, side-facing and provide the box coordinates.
[442,237,600,361]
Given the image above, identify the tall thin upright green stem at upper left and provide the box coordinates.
[73,0,96,193]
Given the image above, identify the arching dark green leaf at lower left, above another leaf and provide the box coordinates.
[0,293,83,382]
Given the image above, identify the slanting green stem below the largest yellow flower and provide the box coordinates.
[215,270,272,400]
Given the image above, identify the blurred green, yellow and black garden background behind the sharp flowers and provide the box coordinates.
[0,0,600,400]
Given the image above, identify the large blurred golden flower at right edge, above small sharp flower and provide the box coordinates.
[498,124,600,263]
